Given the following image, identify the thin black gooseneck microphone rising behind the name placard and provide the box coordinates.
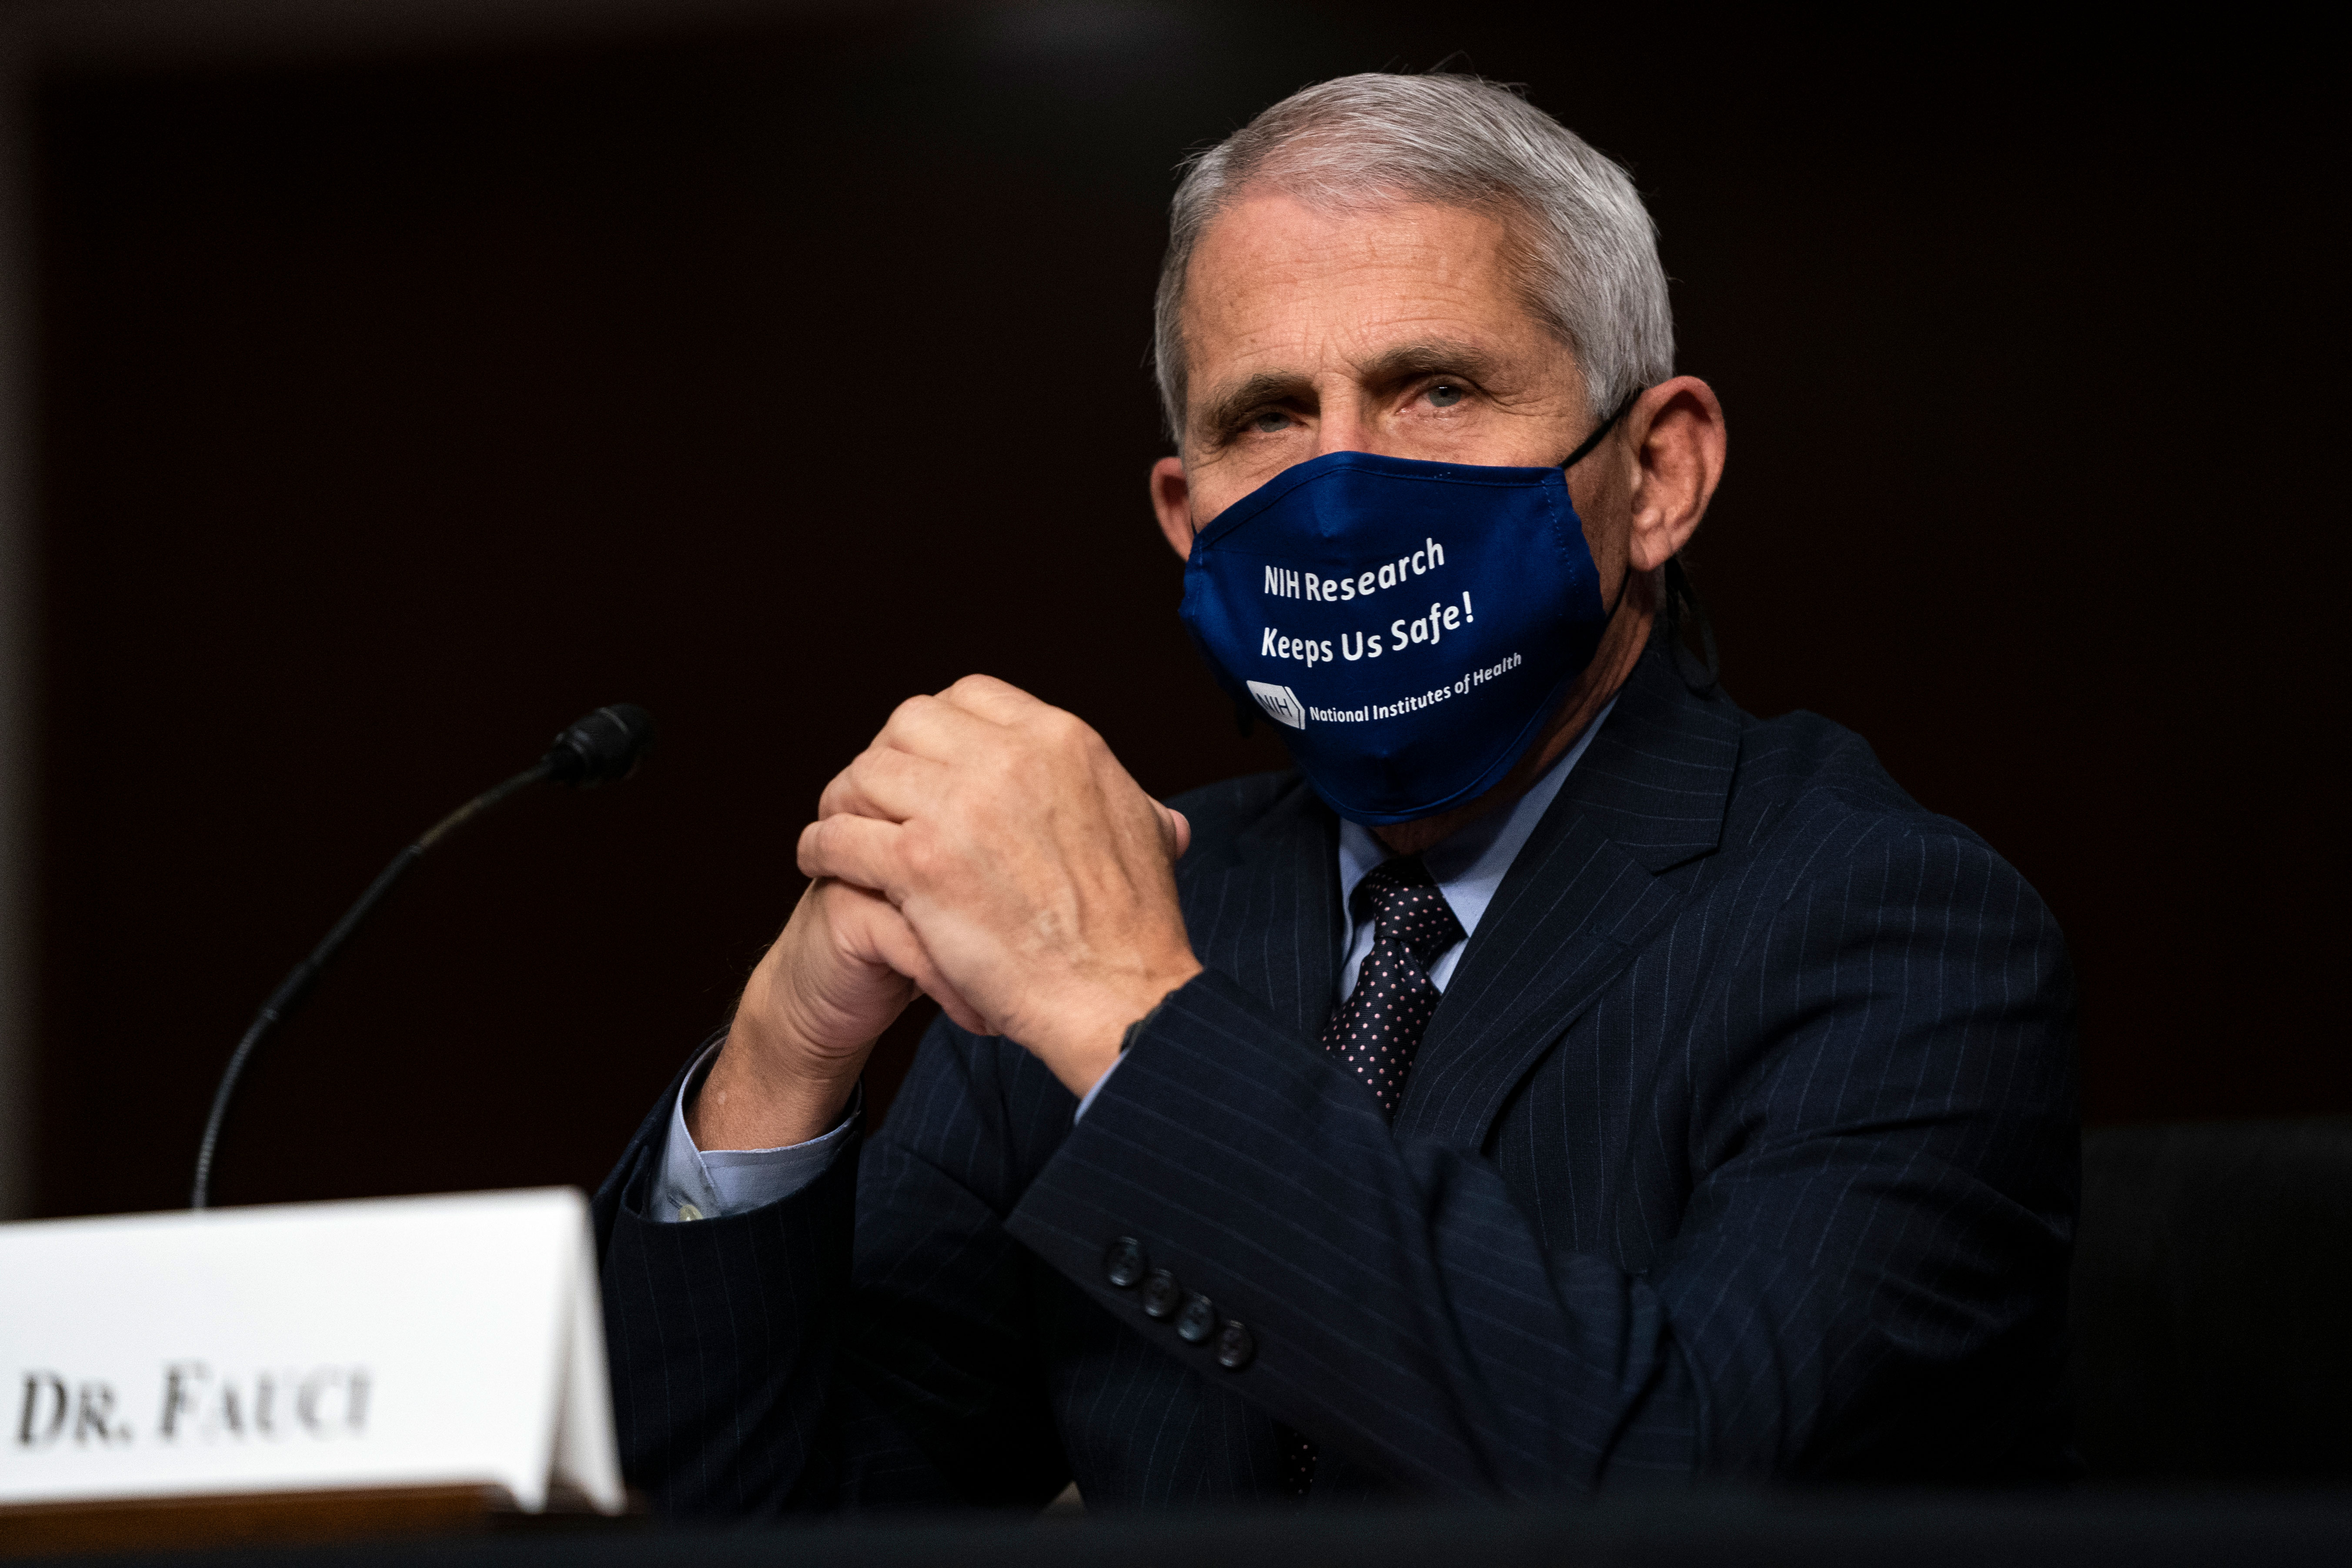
[188,703,654,1208]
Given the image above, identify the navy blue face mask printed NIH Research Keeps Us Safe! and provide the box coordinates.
[1181,400,1632,825]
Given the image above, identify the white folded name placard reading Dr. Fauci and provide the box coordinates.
[0,1187,623,1511]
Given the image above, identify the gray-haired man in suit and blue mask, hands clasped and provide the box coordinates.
[598,75,2075,1514]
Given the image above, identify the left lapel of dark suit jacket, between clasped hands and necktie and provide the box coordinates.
[1178,778,1341,1039]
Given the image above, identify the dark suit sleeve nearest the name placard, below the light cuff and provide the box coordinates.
[595,1023,1068,1518]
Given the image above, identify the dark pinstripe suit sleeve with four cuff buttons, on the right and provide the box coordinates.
[1011,827,2075,1498]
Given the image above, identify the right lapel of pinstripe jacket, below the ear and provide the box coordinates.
[1397,646,1741,1152]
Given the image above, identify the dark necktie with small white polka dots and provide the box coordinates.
[1282,856,1463,1498]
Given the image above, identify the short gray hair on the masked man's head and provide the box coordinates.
[1153,73,1674,445]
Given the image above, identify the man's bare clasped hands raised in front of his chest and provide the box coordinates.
[692,675,1199,1150]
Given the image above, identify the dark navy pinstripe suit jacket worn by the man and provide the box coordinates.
[598,649,2077,1514]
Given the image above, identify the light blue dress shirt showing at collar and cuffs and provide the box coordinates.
[651,698,1616,1220]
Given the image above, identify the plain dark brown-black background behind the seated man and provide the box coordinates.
[13,2,2352,1213]
